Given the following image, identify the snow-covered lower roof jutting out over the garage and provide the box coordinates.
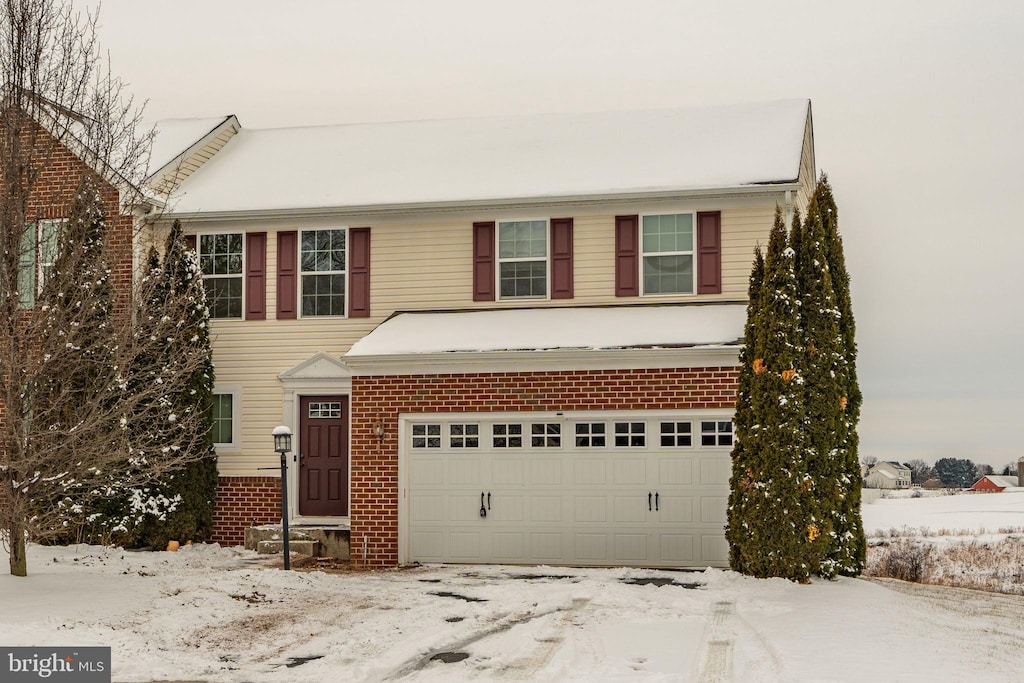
[345,304,746,358]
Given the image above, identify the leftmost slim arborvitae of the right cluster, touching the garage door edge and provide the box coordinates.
[725,245,765,573]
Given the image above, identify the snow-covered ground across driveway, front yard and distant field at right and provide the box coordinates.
[0,494,1024,683]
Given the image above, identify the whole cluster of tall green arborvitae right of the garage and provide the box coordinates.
[726,175,866,581]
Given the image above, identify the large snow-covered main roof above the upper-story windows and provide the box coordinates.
[167,99,810,215]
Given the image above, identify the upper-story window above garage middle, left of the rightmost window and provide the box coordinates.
[498,220,548,299]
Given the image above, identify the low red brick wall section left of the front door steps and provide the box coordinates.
[210,476,281,546]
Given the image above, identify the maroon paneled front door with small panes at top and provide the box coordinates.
[299,396,348,517]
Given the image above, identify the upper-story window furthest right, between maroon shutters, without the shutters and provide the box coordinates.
[640,213,693,294]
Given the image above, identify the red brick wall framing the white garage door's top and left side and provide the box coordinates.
[350,368,739,566]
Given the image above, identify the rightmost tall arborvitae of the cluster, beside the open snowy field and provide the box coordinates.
[808,173,867,577]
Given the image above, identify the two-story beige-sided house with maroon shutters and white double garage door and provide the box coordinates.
[148,100,815,566]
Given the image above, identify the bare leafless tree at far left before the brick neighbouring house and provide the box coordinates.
[0,0,209,575]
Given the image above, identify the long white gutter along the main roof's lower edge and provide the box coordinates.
[161,181,800,223]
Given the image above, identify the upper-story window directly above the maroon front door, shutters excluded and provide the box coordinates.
[300,228,345,317]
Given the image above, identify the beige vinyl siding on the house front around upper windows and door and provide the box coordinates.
[198,197,781,475]
